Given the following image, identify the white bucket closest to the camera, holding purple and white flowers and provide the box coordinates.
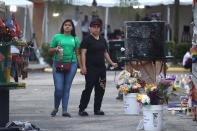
[143,105,163,131]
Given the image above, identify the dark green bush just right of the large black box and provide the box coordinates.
[166,41,192,64]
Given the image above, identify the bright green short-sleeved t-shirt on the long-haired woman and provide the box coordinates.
[50,34,79,62]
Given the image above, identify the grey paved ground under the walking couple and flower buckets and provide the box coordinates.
[10,71,197,131]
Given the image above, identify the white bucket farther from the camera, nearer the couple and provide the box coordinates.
[123,93,140,115]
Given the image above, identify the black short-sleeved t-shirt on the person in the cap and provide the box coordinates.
[80,35,107,68]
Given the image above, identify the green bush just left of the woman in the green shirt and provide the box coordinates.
[40,43,53,66]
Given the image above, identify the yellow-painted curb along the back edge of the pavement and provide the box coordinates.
[44,67,190,73]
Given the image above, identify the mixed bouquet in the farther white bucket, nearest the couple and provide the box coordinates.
[118,69,146,95]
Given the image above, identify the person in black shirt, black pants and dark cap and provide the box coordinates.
[79,19,118,116]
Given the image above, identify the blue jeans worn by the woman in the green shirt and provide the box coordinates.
[53,61,77,112]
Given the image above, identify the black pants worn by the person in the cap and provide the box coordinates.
[79,67,106,112]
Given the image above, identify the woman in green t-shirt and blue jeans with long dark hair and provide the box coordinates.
[48,20,81,117]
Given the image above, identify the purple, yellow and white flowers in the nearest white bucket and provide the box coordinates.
[137,74,173,105]
